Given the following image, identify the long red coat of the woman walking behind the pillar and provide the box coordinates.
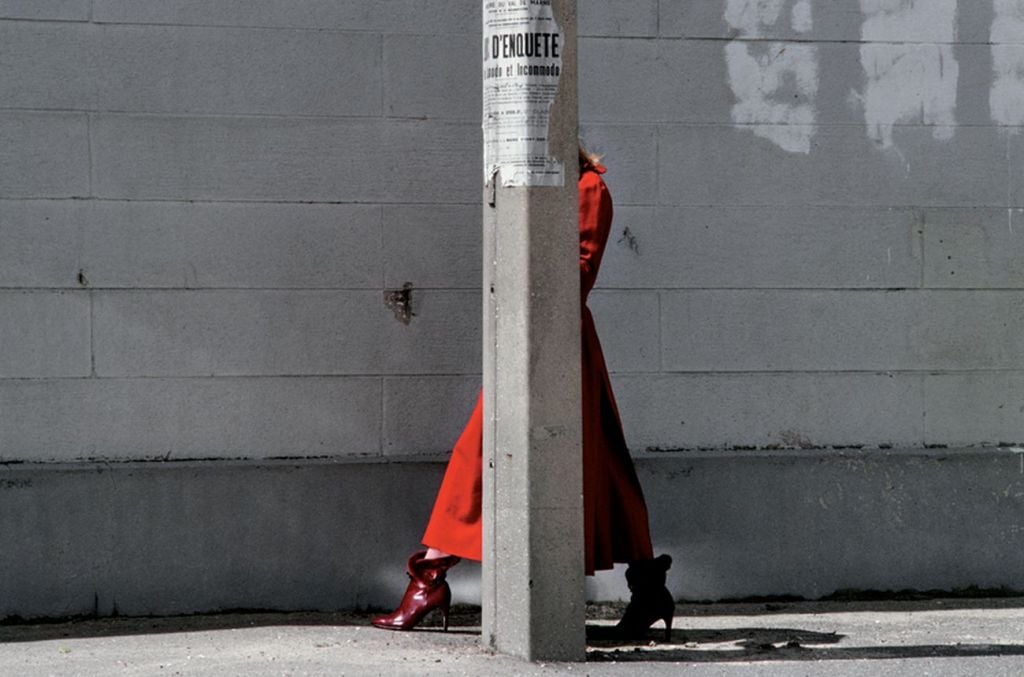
[423,167,653,574]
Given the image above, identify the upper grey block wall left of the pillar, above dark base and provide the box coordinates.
[0,0,480,462]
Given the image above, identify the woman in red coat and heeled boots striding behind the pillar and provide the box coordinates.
[373,146,674,635]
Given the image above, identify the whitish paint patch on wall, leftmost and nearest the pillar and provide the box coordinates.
[725,0,818,153]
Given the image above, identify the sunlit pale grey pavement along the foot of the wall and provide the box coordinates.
[0,598,1024,677]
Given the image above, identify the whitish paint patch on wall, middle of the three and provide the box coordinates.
[859,0,959,147]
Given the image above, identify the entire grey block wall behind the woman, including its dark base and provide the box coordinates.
[6,0,1024,617]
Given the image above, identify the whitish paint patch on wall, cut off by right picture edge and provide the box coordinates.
[988,0,1024,132]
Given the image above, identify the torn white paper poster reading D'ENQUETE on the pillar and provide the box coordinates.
[483,0,565,186]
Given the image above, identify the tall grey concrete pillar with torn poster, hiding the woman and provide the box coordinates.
[481,0,586,661]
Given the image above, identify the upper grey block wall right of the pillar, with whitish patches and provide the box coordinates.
[581,0,1024,451]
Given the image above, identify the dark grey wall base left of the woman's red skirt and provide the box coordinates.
[0,461,448,618]
